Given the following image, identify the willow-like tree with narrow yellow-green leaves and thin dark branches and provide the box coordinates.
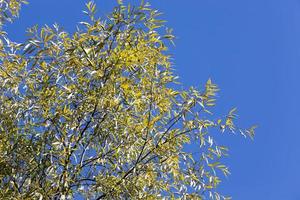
[0,0,255,199]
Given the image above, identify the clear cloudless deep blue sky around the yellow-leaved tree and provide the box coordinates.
[6,0,300,200]
